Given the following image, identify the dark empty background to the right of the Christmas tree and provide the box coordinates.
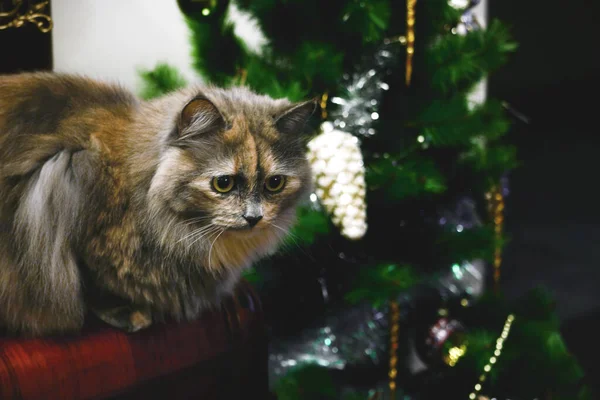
[489,0,600,393]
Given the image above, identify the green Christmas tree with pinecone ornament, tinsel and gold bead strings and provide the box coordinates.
[142,0,590,399]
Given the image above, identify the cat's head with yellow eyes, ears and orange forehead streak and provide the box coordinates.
[151,91,315,266]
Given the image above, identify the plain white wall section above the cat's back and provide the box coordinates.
[52,0,199,90]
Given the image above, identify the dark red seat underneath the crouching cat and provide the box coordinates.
[0,284,268,400]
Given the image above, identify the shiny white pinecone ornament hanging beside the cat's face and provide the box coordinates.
[308,122,367,240]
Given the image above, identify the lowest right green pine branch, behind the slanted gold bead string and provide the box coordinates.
[457,288,589,399]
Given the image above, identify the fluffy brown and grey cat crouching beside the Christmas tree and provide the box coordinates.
[0,73,316,336]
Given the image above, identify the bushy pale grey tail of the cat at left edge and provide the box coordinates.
[0,150,84,334]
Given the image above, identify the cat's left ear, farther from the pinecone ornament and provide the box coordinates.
[177,96,226,139]
